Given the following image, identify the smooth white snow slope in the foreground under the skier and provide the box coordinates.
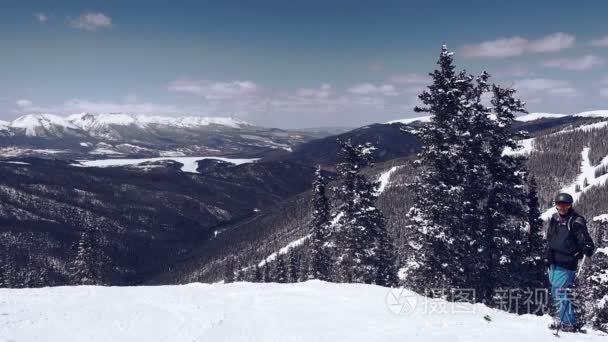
[0,281,605,342]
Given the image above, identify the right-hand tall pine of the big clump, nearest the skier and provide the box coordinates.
[471,82,528,305]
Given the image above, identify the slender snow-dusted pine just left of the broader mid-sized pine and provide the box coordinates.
[309,165,333,280]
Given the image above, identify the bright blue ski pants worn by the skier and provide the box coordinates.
[549,264,576,324]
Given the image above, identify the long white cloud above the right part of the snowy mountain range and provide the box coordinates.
[169,79,260,100]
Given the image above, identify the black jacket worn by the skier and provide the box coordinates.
[545,210,595,271]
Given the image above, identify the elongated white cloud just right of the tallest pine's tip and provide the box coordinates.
[462,32,576,58]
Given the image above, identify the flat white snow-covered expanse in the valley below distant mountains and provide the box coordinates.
[72,157,258,173]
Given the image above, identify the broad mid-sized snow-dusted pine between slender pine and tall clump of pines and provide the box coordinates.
[333,140,397,286]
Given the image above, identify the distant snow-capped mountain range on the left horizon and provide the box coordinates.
[0,113,331,159]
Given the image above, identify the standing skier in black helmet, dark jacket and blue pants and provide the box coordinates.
[545,193,595,332]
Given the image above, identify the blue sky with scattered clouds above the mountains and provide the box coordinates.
[0,0,608,128]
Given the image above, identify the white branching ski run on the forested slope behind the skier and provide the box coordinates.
[540,148,608,221]
